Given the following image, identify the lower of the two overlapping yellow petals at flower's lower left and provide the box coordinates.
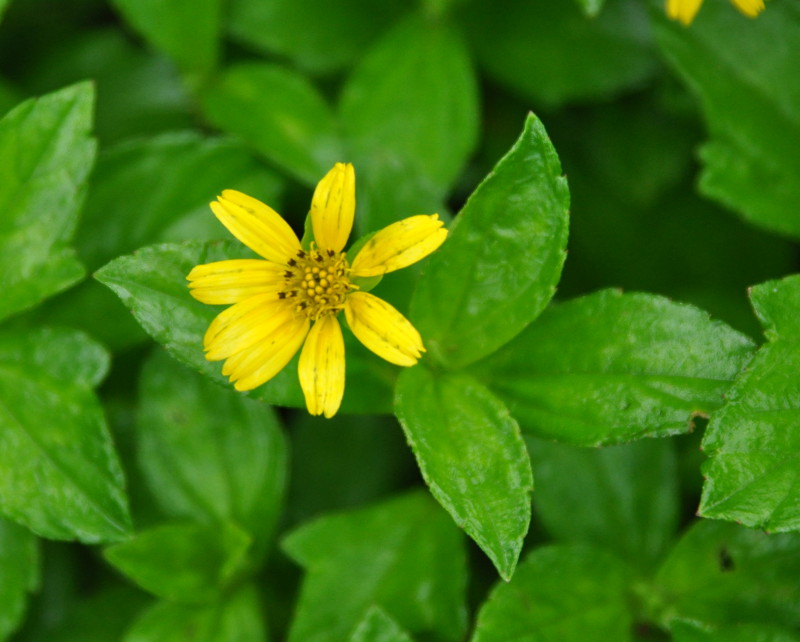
[222,316,311,390]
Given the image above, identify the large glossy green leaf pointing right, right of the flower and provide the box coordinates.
[475,290,753,446]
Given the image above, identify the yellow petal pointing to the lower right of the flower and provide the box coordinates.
[344,292,425,366]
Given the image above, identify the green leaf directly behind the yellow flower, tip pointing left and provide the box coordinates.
[95,241,397,413]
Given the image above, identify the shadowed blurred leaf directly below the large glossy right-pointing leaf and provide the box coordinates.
[527,438,679,573]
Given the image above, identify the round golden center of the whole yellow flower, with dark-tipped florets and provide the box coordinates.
[278,243,356,320]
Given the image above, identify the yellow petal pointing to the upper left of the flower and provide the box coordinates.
[211,189,300,264]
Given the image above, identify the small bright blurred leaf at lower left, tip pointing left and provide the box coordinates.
[103,523,252,604]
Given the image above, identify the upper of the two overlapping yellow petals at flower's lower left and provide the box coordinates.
[203,294,294,361]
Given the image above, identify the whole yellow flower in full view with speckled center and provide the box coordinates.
[186,163,447,418]
